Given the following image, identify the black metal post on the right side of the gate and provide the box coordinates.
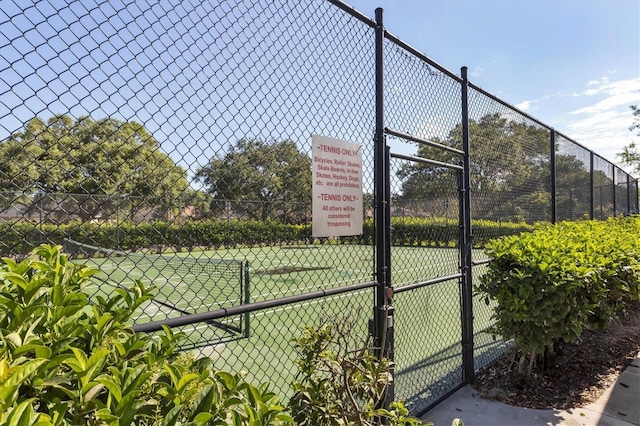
[460,67,475,383]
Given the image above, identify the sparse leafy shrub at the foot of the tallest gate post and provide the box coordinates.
[289,318,432,426]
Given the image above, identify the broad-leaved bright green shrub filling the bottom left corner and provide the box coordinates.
[0,245,292,426]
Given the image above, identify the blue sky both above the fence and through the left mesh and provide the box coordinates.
[0,0,640,177]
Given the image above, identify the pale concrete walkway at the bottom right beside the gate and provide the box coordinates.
[422,353,640,426]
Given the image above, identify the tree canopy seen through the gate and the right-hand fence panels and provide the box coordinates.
[395,110,620,223]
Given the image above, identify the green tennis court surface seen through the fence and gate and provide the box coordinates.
[85,245,500,399]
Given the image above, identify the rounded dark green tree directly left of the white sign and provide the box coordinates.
[196,139,312,223]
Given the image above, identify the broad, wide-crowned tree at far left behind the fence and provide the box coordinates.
[0,115,189,220]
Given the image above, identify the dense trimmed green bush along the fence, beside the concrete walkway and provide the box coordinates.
[477,218,640,372]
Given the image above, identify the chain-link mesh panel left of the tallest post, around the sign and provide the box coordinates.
[0,1,374,402]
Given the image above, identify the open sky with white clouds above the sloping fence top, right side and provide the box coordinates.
[346,0,640,170]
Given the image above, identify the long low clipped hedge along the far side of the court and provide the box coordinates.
[0,217,532,256]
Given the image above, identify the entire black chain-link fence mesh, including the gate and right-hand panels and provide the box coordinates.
[0,0,638,414]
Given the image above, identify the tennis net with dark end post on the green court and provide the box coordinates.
[63,239,250,344]
